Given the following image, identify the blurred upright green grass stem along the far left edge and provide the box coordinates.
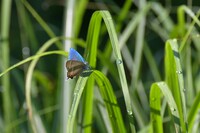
[0,0,16,133]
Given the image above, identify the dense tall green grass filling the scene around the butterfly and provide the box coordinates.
[0,0,200,133]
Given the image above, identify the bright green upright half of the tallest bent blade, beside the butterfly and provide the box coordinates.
[79,12,102,133]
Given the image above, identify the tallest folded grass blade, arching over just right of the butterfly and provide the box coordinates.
[81,11,134,130]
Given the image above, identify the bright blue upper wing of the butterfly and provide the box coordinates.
[68,48,85,63]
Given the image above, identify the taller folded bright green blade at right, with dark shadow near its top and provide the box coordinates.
[165,40,187,132]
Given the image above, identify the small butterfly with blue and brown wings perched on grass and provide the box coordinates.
[66,48,90,79]
